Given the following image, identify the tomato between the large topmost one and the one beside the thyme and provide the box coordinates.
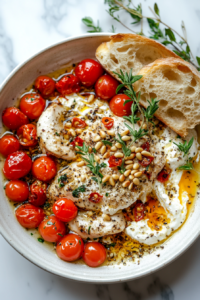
[95,74,119,100]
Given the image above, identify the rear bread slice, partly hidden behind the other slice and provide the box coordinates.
[96,33,178,79]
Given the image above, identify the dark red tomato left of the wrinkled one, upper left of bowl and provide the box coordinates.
[35,75,56,97]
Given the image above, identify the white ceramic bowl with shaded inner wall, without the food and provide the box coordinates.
[0,33,200,283]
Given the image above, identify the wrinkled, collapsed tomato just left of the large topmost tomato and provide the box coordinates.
[56,74,81,96]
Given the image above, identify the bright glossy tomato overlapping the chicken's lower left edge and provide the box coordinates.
[53,198,78,223]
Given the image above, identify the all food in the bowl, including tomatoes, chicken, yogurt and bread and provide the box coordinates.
[0,35,199,267]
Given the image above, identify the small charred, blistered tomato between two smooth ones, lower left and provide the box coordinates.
[28,180,47,206]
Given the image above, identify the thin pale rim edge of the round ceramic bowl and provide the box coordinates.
[0,32,200,284]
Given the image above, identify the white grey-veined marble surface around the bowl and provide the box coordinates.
[0,0,200,300]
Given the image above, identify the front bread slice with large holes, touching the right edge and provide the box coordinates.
[134,58,200,137]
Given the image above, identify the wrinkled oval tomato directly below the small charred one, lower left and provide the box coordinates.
[15,204,45,228]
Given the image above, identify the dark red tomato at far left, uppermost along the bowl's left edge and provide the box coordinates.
[2,107,29,130]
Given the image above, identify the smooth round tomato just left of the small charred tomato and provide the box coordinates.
[5,180,29,202]
